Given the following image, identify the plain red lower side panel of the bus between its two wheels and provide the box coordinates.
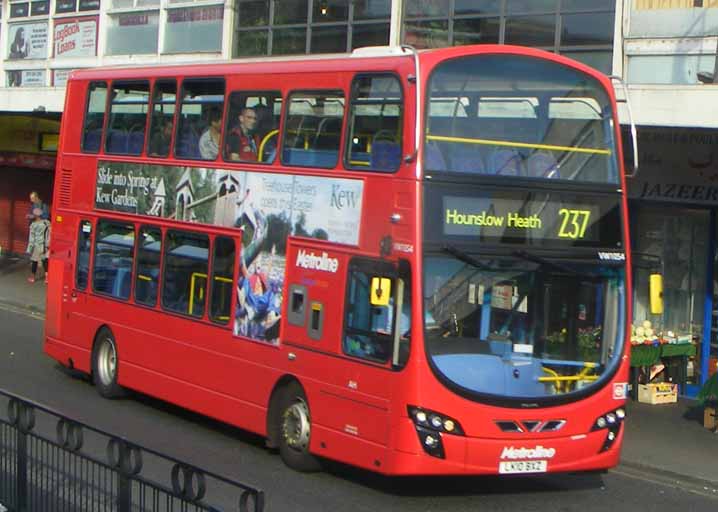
[88,296,280,434]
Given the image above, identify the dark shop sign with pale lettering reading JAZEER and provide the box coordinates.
[627,127,718,206]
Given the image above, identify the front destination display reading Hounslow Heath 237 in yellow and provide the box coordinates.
[425,186,622,248]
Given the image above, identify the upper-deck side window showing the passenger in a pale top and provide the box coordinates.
[175,78,224,160]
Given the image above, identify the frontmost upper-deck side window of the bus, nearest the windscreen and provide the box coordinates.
[347,75,403,171]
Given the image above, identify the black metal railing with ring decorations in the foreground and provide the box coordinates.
[0,390,264,512]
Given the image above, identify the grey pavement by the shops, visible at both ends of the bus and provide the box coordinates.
[0,255,718,490]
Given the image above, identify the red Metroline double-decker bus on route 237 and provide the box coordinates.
[45,45,631,475]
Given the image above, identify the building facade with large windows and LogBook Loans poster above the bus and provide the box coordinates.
[0,0,620,112]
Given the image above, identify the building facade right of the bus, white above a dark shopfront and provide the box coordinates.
[614,0,718,395]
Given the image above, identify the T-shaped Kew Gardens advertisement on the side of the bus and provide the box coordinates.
[95,162,363,343]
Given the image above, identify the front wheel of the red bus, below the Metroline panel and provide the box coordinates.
[277,382,320,472]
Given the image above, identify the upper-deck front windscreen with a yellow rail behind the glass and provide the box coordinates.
[424,55,618,184]
